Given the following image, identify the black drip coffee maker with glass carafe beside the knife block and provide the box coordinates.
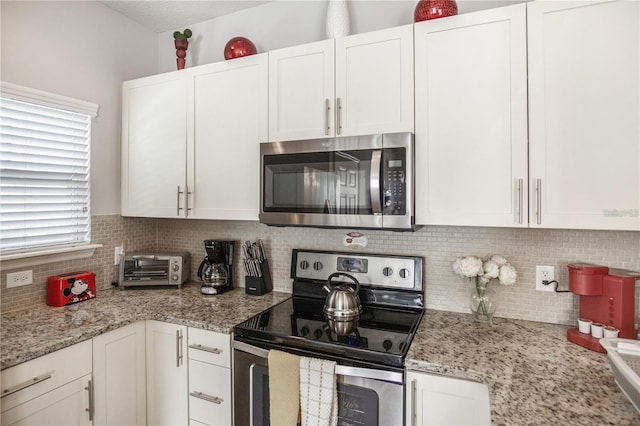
[198,240,235,294]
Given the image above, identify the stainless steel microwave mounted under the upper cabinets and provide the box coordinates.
[260,133,415,231]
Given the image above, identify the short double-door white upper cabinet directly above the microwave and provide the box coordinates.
[269,25,414,141]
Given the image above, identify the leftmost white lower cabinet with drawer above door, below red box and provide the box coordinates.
[0,340,93,426]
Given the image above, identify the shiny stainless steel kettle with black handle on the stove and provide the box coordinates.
[323,272,362,336]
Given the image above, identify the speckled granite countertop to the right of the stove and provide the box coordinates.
[405,309,640,426]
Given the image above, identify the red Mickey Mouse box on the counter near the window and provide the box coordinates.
[47,271,96,306]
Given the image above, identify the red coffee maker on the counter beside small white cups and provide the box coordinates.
[567,263,640,352]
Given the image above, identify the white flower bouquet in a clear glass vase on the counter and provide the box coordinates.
[452,255,518,321]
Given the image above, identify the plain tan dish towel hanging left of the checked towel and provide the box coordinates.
[268,349,300,426]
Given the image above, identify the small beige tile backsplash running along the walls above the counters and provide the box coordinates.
[0,215,640,324]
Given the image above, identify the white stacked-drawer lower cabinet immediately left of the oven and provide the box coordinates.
[189,328,232,426]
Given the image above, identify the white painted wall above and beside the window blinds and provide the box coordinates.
[0,0,158,215]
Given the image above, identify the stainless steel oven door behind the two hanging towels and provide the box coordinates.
[233,341,404,426]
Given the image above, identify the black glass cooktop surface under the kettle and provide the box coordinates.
[235,296,422,367]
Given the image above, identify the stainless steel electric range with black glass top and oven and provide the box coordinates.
[233,249,424,425]
